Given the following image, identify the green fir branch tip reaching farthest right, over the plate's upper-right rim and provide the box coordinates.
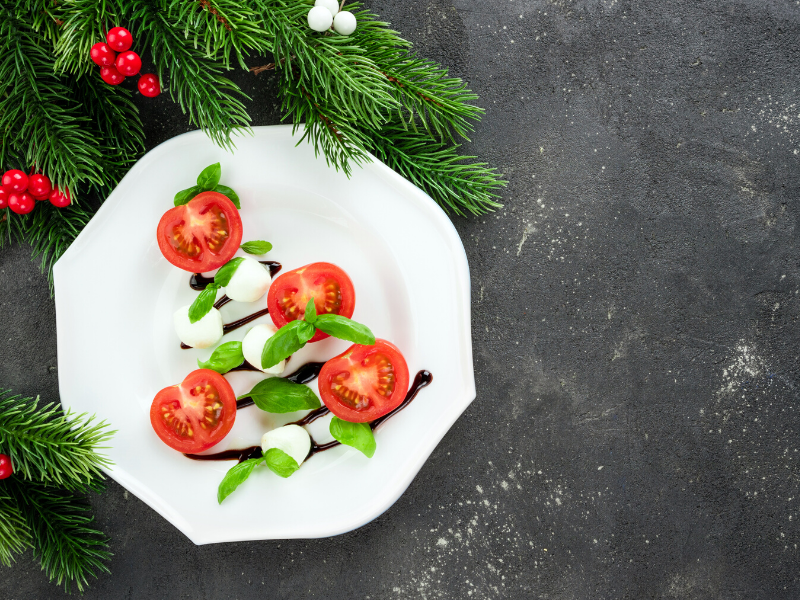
[371,124,506,216]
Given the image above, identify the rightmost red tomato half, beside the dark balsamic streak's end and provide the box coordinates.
[319,340,408,423]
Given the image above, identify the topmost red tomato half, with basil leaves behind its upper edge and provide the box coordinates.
[157,192,242,273]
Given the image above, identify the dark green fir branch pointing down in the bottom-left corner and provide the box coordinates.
[3,475,111,592]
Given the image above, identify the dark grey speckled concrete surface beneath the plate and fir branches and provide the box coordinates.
[0,0,800,600]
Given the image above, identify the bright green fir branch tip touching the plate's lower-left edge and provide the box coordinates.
[0,390,113,490]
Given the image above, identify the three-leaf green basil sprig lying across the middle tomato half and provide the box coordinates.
[261,298,375,369]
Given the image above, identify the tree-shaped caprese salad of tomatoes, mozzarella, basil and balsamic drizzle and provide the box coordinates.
[150,163,432,503]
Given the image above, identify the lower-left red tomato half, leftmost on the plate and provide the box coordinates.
[150,369,236,453]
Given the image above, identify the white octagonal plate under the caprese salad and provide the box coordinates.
[54,126,475,544]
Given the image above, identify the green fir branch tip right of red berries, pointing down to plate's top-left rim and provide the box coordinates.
[130,0,250,149]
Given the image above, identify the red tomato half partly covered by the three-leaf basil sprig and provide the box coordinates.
[267,263,356,342]
